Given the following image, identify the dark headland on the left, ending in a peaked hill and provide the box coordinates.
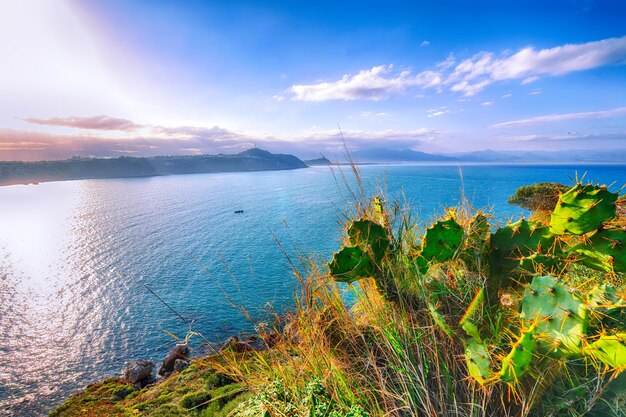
[0,148,307,185]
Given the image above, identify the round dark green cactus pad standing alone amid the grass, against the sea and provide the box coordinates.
[422,219,463,262]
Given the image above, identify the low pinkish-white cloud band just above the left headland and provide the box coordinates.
[0,118,439,161]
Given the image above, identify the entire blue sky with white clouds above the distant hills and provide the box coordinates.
[0,0,626,160]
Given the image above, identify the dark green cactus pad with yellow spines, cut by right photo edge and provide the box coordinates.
[570,229,626,273]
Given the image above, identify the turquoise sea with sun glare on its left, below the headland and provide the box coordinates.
[0,166,626,416]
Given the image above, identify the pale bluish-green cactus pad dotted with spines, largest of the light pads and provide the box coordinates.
[520,276,589,357]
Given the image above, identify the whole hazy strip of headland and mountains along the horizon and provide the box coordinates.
[0,148,626,185]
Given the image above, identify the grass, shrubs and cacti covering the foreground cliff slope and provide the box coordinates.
[53,176,626,417]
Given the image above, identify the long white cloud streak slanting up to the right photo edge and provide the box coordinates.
[287,36,626,101]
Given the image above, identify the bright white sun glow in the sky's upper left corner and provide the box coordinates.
[0,0,130,127]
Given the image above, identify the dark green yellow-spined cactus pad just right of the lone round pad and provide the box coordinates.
[491,219,555,276]
